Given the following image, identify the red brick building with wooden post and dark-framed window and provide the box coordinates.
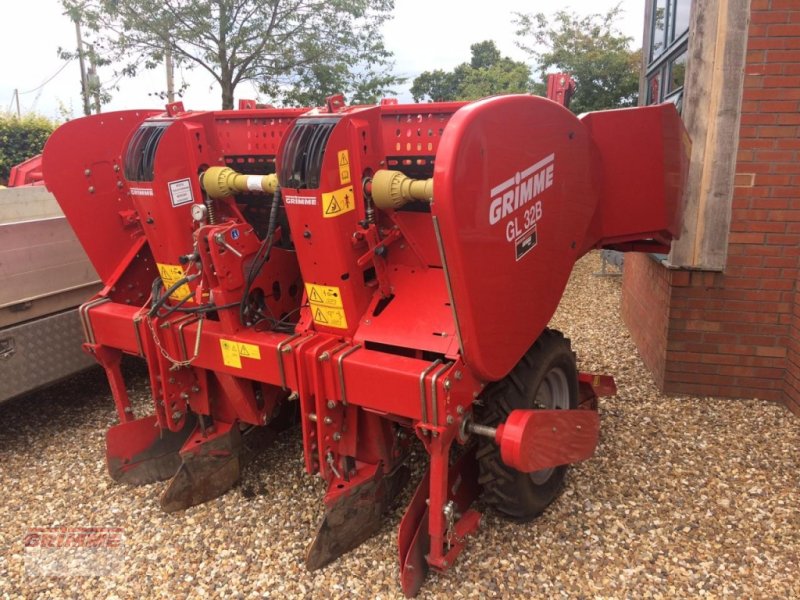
[622,0,800,414]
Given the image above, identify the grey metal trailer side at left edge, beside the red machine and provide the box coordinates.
[0,185,101,402]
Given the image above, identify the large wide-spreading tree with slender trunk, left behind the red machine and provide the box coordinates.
[61,0,400,109]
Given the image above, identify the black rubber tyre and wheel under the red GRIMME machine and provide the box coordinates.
[476,329,578,521]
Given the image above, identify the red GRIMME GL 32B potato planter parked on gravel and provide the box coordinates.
[39,96,688,596]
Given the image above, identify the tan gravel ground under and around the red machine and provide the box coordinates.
[0,254,800,598]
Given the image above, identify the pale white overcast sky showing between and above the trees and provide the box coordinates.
[0,0,644,117]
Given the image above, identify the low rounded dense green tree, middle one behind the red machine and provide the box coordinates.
[411,41,532,102]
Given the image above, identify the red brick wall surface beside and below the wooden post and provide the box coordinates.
[622,0,800,414]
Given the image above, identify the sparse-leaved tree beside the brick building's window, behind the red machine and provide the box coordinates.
[514,5,641,113]
